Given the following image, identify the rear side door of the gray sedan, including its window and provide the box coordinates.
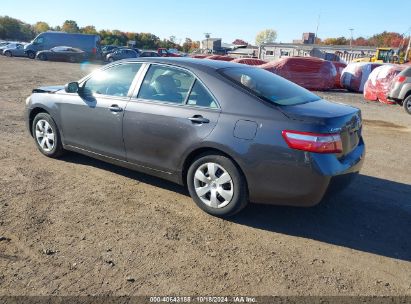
[123,64,220,173]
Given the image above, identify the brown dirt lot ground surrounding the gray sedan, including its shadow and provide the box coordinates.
[0,57,411,295]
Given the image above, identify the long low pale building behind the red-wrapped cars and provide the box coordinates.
[258,42,376,63]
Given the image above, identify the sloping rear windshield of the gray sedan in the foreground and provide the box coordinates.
[220,67,320,106]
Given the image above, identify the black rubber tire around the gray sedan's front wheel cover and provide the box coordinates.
[32,113,65,158]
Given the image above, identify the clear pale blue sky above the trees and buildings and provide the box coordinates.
[0,0,411,43]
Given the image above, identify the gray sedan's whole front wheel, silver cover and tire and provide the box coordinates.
[32,113,64,158]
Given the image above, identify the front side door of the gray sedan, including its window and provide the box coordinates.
[60,63,141,160]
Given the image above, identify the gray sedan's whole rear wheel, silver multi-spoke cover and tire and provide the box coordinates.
[187,155,248,217]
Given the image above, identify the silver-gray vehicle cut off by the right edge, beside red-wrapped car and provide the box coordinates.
[388,67,411,115]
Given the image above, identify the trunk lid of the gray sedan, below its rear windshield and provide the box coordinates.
[279,99,362,157]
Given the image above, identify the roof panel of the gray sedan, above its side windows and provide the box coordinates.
[117,57,252,70]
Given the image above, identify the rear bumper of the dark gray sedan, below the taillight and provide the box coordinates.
[249,139,365,207]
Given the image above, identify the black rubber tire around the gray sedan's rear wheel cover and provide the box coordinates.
[187,154,248,217]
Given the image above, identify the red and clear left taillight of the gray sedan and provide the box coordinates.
[282,130,342,153]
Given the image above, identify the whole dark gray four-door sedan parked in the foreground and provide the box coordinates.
[26,58,365,216]
